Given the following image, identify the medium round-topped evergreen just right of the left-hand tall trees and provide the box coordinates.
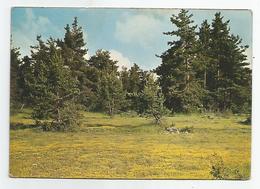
[88,50,125,113]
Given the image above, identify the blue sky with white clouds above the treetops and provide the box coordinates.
[11,8,252,70]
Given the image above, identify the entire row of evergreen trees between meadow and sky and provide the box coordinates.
[10,9,251,130]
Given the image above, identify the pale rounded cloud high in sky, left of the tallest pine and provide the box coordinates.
[115,14,168,47]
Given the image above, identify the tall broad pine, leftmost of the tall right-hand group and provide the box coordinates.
[155,9,203,112]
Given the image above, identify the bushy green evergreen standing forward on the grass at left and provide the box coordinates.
[26,36,79,131]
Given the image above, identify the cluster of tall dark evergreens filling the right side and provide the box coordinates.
[155,10,251,113]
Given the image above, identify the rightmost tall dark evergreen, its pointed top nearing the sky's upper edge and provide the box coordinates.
[208,13,250,111]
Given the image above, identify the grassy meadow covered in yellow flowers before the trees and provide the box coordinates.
[10,111,251,179]
